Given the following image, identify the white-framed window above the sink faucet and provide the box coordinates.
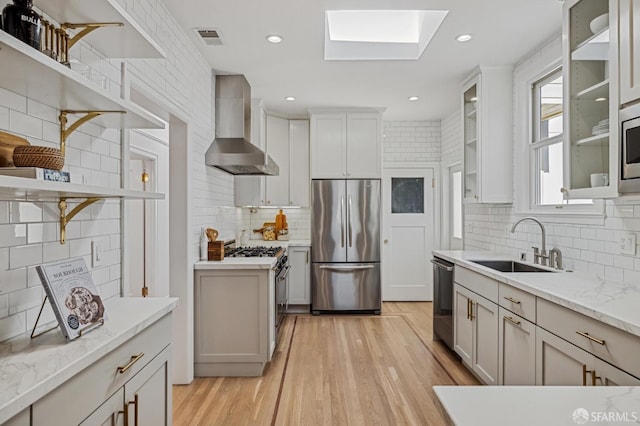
[529,68,594,210]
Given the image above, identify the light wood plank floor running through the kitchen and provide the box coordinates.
[173,302,478,426]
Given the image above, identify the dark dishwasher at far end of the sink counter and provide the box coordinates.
[431,257,453,350]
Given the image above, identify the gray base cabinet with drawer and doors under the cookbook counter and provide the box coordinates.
[31,315,173,426]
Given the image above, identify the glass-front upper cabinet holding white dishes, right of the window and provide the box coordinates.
[562,0,619,199]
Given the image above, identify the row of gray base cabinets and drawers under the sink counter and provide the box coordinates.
[453,265,640,386]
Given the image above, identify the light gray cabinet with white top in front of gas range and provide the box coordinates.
[194,257,277,377]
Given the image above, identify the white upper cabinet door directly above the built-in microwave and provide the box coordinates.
[619,0,640,105]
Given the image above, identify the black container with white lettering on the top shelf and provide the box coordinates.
[2,0,42,50]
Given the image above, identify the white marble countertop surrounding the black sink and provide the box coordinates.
[433,250,640,336]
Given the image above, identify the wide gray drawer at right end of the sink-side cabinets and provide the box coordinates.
[536,299,640,377]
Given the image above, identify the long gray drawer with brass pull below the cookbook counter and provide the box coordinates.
[31,315,171,426]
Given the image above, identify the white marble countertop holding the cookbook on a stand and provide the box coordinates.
[0,297,178,424]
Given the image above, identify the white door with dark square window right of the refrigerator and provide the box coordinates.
[382,168,435,301]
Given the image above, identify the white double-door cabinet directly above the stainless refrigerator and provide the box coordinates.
[311,112,382,179]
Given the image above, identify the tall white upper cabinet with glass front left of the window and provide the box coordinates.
[461,66,513,203]
